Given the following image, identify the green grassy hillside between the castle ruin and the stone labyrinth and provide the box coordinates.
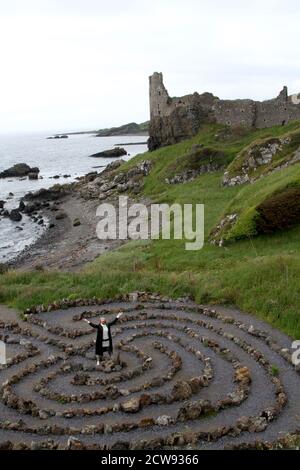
[0,122,300,338]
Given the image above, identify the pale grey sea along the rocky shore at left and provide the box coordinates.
[0,134,147,264]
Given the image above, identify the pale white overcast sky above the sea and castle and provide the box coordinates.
[0,0,300,133]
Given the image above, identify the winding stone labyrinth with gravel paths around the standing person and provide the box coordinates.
[0,293,300,449]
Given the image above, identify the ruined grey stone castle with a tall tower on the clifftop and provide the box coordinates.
[149,72,300,150]
